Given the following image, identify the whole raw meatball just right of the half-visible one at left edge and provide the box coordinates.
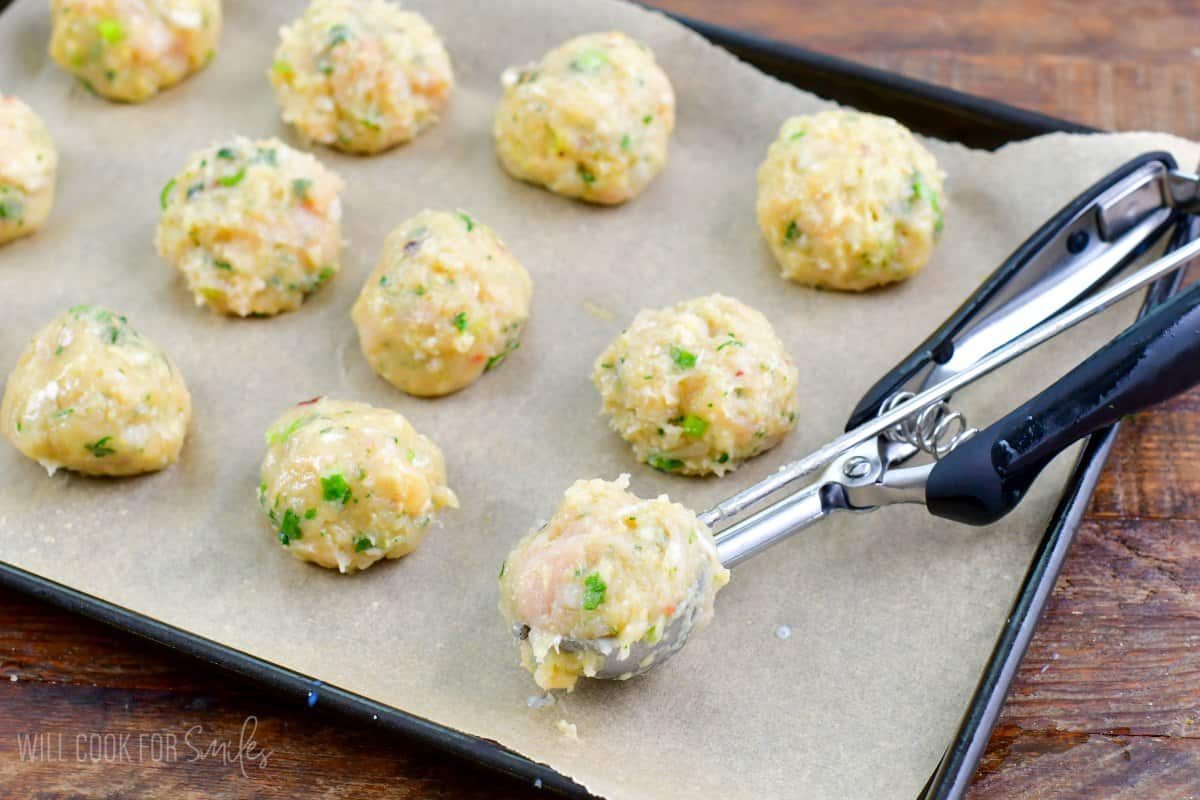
[155,137,342,317]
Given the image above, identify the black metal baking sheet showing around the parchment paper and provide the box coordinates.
[0,7,1166,800]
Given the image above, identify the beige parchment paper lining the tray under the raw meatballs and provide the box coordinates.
[0,0,1198,799]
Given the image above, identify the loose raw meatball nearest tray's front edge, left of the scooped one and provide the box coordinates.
[258,398,458,572]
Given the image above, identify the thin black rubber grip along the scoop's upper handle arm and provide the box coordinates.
[846,152,1176,431]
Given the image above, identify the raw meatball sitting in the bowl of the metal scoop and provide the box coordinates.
[500,475,730,690]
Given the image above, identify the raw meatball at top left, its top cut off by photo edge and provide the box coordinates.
[50,0,221,103]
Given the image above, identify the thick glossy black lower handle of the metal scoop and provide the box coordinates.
[925,275,1200,525]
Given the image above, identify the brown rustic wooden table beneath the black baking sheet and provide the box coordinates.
[0,0,1200,800]
